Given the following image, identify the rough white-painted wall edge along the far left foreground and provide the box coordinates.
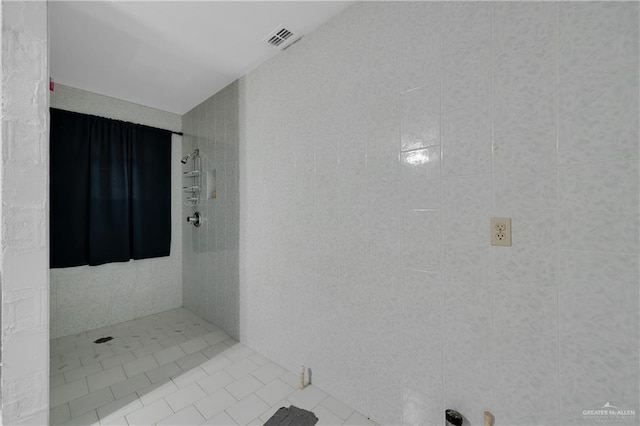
[0,1,49,425]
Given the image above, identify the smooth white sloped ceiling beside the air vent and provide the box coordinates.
[49,1,351,114]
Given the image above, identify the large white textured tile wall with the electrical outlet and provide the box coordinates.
[232,2,639,425]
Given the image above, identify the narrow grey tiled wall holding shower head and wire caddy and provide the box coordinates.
[182,83,239,338]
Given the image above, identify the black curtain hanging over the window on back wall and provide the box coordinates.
[50,108,171,268]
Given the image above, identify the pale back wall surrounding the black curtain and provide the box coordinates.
[50,84,183,338]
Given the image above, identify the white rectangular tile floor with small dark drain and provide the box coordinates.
[50,309,374,426]
